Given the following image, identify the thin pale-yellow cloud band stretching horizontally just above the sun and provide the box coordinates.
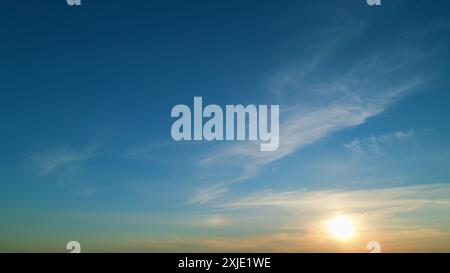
[215,184,450,214]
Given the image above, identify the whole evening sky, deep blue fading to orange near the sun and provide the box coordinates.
[0,0,450,252]
